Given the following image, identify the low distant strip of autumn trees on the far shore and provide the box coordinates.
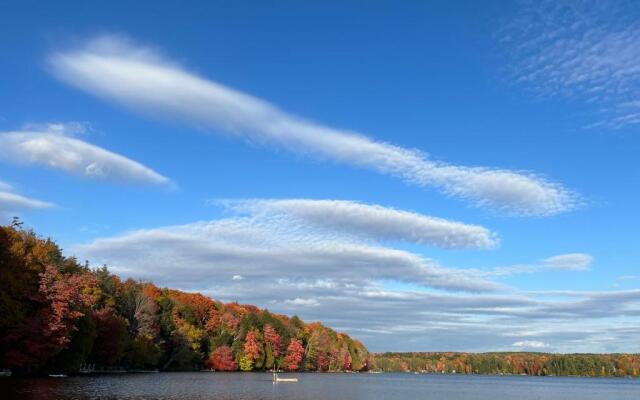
[371,352,640,377]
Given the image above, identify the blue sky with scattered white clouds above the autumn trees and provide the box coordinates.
[0,2,640,351]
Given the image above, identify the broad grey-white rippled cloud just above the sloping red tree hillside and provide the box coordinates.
[76,218,500,291]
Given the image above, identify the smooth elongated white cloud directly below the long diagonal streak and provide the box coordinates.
[222,199,499,249]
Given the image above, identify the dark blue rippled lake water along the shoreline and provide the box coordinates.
[0,372,640,400]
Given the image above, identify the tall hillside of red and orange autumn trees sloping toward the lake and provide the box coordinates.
[0,221,370,374]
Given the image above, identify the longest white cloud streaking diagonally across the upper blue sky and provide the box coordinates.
[50,36,576,215]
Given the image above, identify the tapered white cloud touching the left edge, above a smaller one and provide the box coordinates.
[0,124,171,185]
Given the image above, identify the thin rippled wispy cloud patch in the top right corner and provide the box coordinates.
[498,0,640,128]
